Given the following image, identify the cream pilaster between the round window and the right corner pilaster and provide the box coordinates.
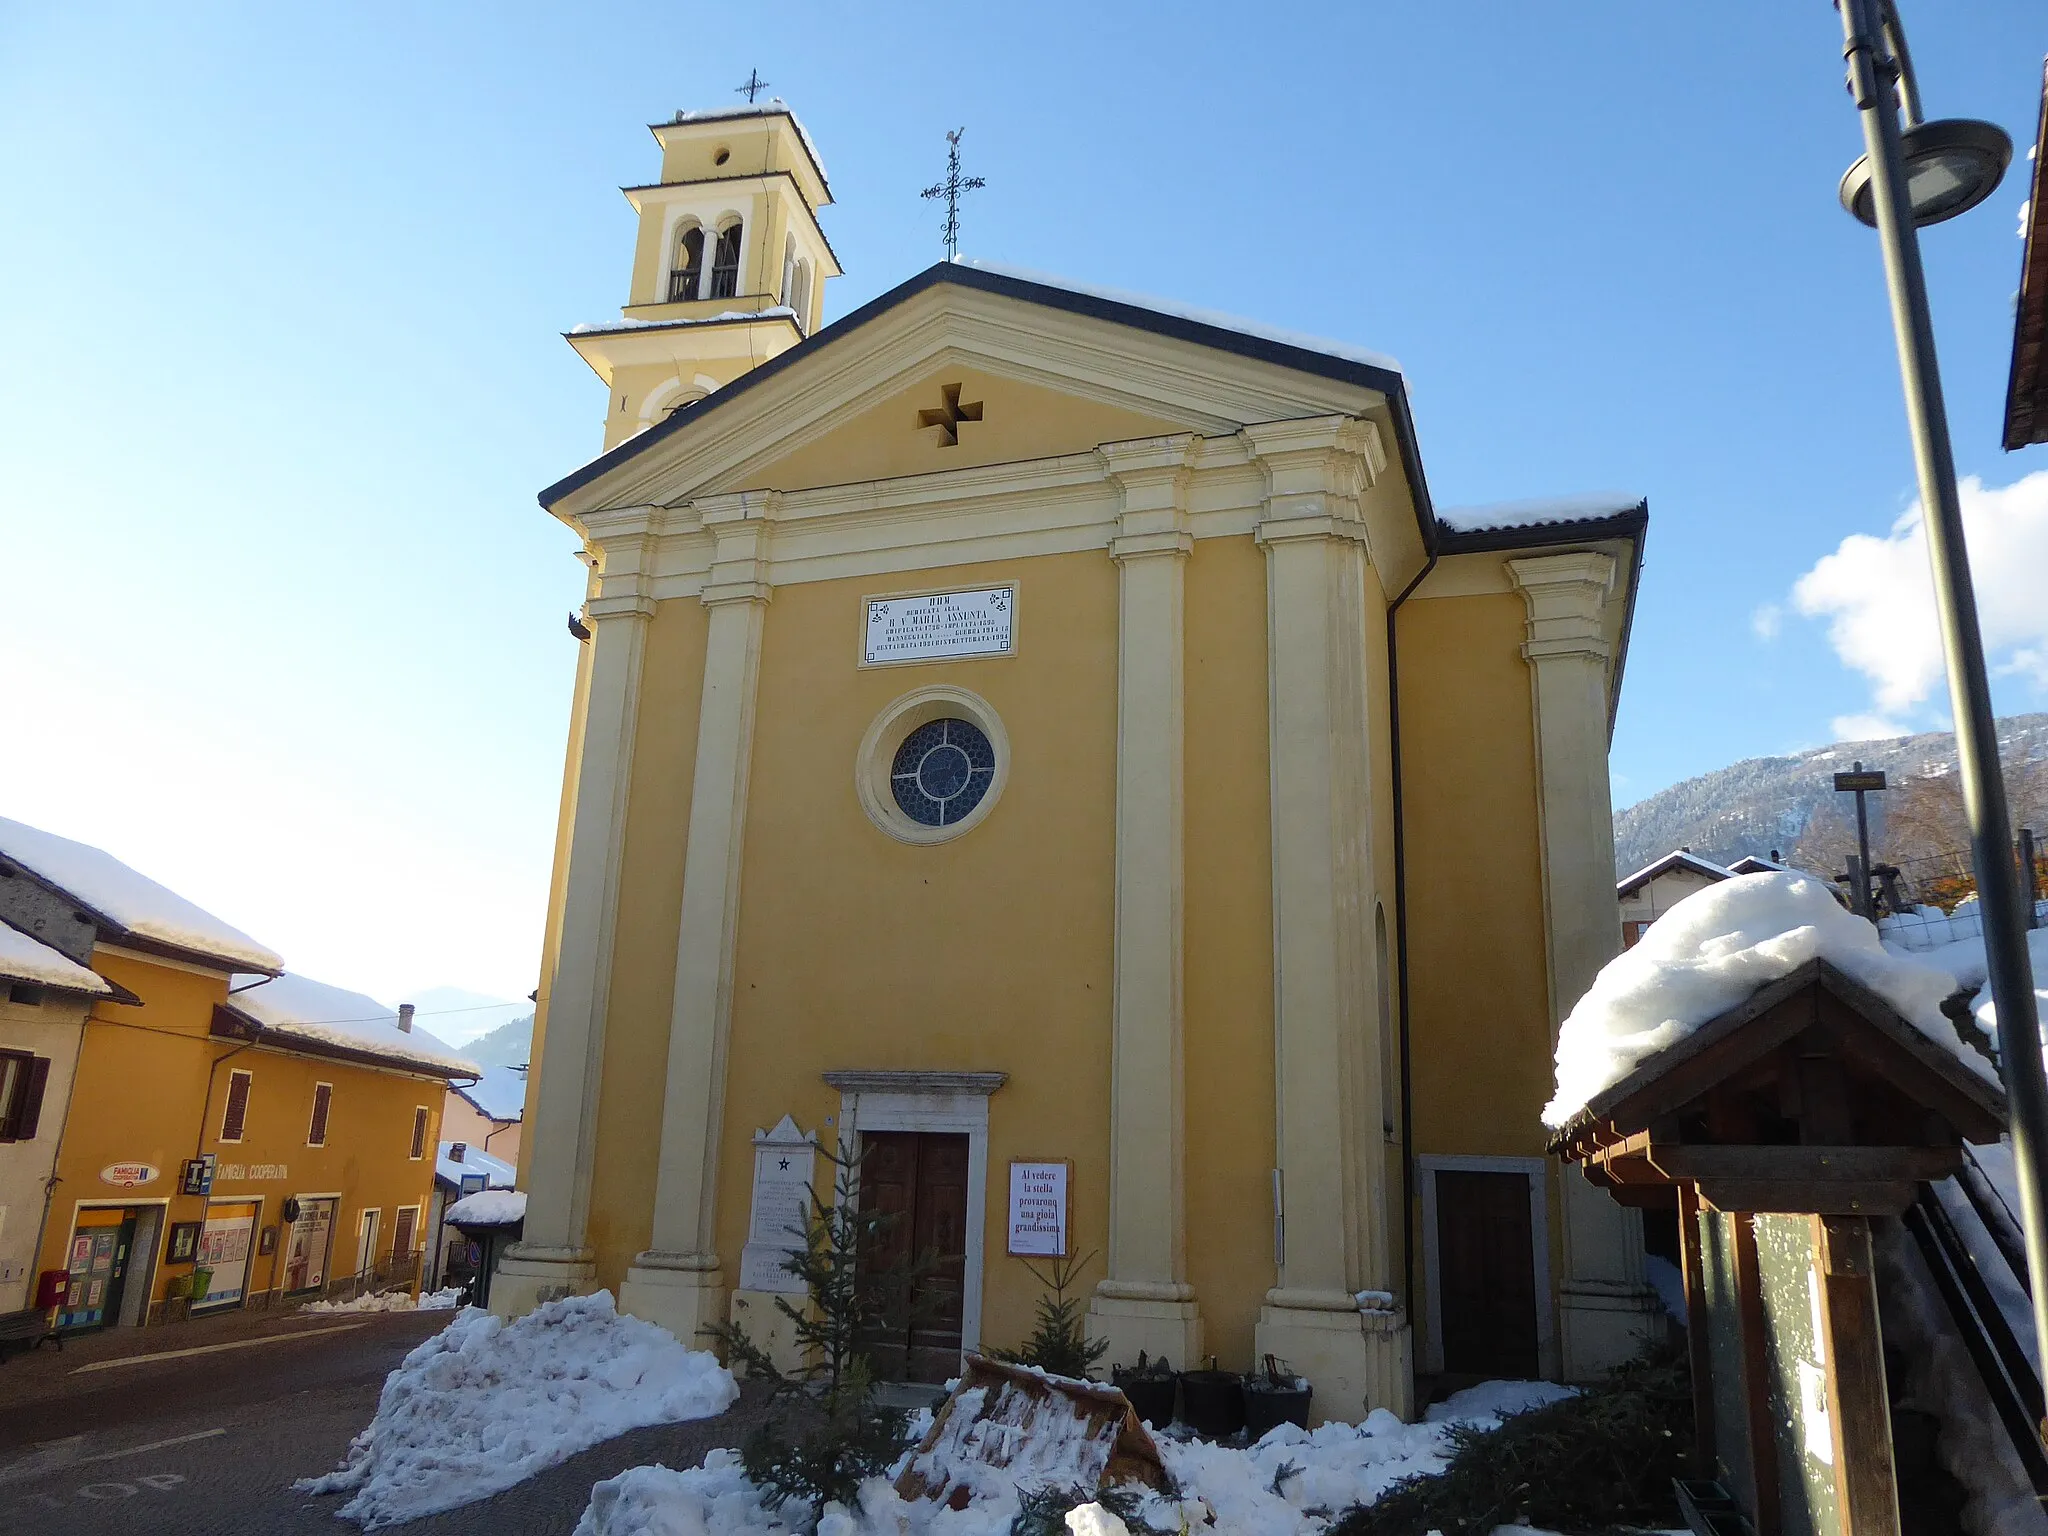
[1090,432,1202,1364]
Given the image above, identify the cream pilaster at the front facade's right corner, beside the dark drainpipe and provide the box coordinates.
[1243,416,1411,1419]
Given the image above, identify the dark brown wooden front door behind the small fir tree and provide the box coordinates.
[860,1130,967,1382]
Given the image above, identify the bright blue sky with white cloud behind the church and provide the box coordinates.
[0,0,2048,1034]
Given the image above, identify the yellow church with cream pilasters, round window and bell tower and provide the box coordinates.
[503,102,1655,1419]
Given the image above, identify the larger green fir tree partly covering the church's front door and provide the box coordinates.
[705,1143,938,1516]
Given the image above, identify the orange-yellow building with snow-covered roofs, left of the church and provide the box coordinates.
[0,819,475,1327]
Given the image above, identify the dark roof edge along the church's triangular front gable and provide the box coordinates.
[539,262,1441,553]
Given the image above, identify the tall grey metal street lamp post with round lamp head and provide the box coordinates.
[1837,0,2048,1434]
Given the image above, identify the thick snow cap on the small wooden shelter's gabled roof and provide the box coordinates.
[1542,872,1997,1128]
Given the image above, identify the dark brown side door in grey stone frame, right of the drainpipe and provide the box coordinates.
[1436,1169,1538,1380]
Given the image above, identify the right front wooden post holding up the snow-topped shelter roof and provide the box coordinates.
[1812,1217,1898,1536]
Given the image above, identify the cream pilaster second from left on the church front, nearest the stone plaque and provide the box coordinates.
[621,492,776,1339]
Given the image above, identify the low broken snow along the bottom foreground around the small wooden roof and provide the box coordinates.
[575,1382,1571,1536]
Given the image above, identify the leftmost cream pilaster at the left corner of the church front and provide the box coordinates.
[492,561,655,1317]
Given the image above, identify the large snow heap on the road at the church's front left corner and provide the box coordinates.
[293,1290,739,1530]
